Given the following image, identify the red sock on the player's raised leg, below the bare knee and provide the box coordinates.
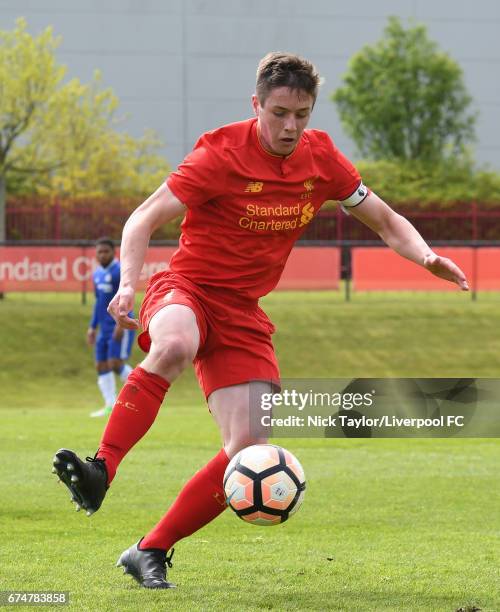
[97,366,170,485]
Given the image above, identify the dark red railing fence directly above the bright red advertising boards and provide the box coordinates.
[6,196,500,241]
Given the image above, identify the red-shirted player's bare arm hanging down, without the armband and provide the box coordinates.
[108,183,186,329]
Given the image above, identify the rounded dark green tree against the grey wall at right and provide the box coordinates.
[332,17,476,163]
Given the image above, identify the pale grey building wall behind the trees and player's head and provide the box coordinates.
[0,0,500,168]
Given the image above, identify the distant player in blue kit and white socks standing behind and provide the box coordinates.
[87,238,135,417]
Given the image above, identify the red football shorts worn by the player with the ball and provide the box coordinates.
[138,271,279,398]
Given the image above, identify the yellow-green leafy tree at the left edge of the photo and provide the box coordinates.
[0,18,168,241]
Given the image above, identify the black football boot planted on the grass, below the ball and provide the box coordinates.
[116,538,176,589]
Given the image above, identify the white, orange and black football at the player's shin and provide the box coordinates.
[224,444,306,525]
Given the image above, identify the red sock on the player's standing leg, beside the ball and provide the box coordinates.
[141,449,229,550]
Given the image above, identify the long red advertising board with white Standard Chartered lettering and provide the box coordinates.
[0,246,340,292]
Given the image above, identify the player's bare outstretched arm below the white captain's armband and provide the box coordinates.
[349,192,469,291]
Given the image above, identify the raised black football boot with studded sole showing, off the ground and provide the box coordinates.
[52,448,108,516]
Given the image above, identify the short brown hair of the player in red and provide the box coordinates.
[255,51,320,105]
